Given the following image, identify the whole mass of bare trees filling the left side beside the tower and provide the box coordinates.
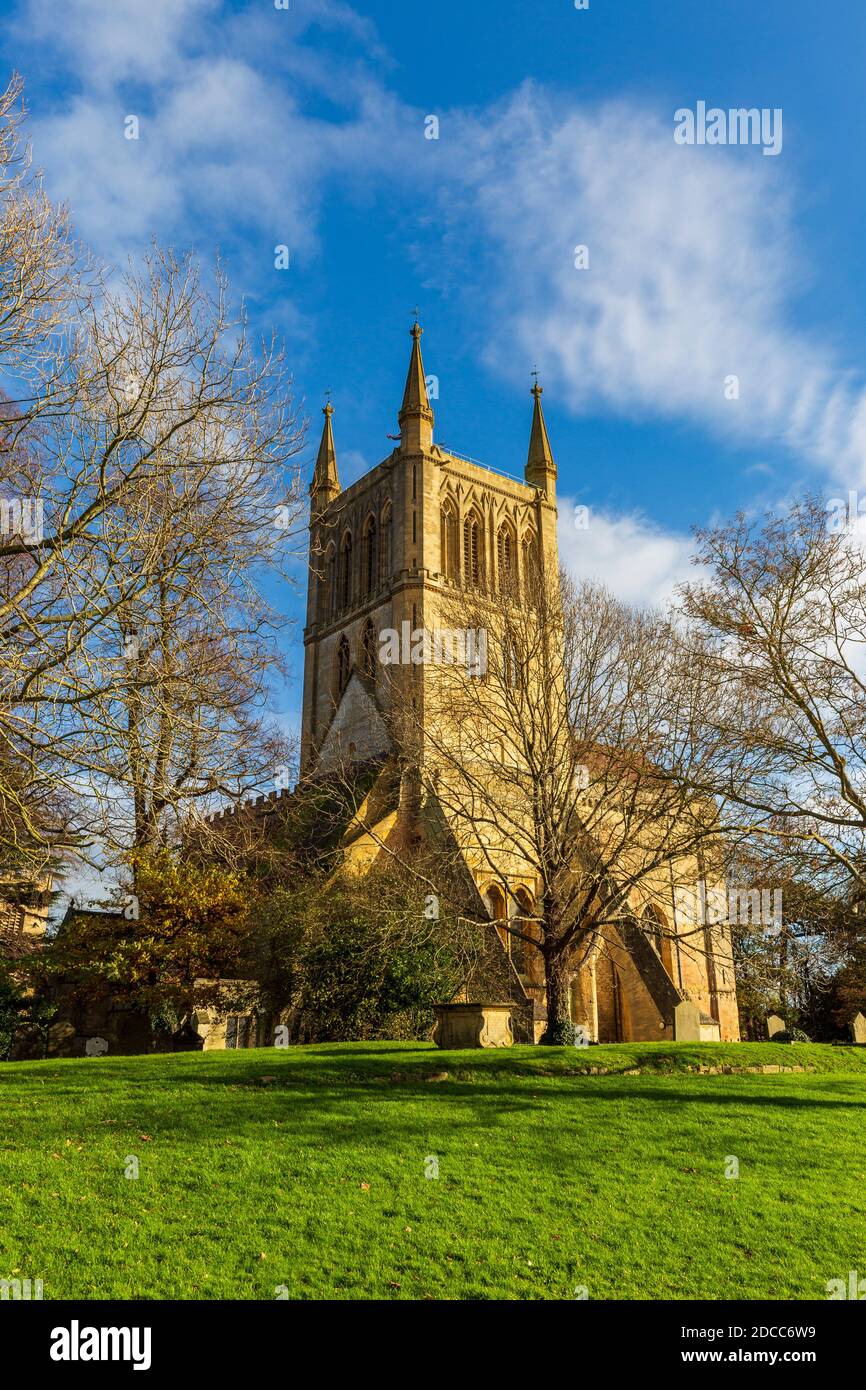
[0,82,303,862]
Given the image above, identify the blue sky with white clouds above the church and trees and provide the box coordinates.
[3,0,866,739]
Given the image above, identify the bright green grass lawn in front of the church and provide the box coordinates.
[0,1043,866,1298]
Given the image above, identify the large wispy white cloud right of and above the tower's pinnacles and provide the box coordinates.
[457,86,866,477]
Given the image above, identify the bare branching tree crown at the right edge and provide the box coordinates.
[683,498,866,904]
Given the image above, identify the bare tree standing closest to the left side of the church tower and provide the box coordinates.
[4,252,303,848]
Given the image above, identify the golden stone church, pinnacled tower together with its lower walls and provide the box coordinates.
[302,322,740,1041]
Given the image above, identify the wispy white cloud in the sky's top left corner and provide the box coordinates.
[19,0,409,271]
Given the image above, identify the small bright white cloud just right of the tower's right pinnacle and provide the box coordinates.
[559,498,695,606]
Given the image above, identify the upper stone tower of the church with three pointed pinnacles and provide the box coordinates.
[302,324,559,777]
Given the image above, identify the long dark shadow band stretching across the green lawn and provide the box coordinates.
[0,1072,866,1166]
